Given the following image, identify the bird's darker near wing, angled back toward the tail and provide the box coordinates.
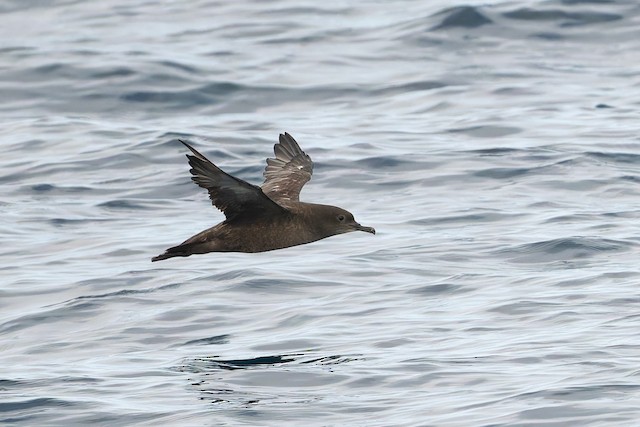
[180,140,285,221]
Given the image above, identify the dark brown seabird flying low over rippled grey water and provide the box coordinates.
[151,133,376,261]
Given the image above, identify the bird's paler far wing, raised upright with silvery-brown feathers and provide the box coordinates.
[262,132,313,202]
